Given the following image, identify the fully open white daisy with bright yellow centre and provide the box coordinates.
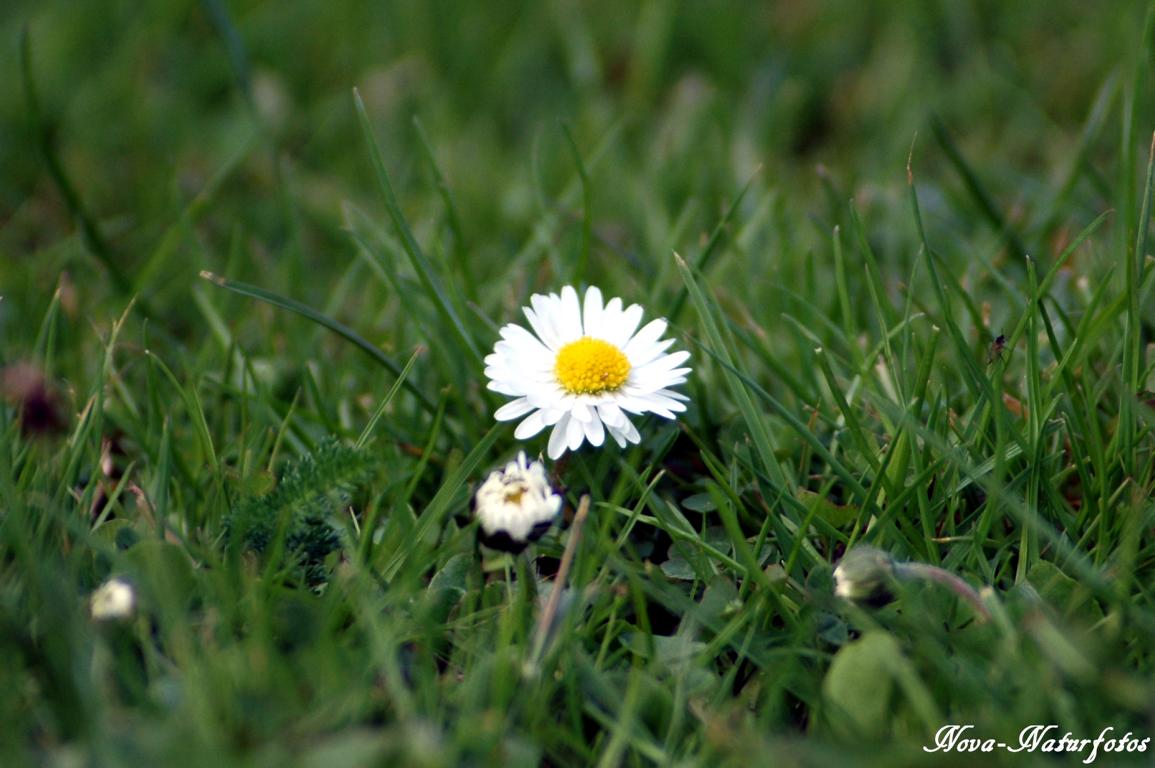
[485,285,690,458]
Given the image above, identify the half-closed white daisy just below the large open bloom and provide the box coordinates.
[474,452,561,553]
